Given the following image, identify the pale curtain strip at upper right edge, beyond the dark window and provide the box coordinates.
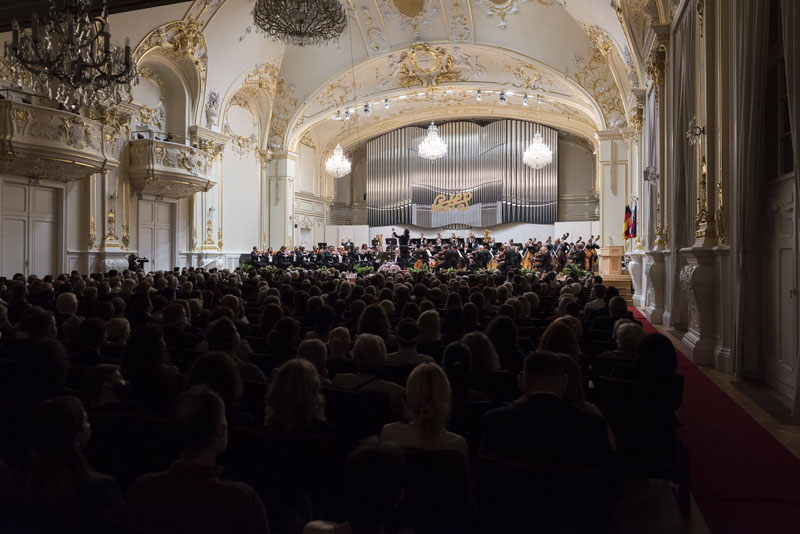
[781,0,800,195]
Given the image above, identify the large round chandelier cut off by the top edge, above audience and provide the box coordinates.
[253,0,347,46]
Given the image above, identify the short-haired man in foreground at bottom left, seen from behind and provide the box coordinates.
[121,386,269,534]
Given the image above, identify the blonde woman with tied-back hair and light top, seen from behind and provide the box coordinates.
[381,363,469,461]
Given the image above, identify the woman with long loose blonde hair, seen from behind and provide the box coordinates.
[264,358,326,437]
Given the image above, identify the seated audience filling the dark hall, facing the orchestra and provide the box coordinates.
[0,269,683,533]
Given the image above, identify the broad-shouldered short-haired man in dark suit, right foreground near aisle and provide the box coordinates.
[480,351,614,482]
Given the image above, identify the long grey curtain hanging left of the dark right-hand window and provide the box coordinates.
[728,0,772,376]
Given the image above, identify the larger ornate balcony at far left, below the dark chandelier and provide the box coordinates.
[0,90,119,182]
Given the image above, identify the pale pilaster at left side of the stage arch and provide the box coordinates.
[266,151,298,249]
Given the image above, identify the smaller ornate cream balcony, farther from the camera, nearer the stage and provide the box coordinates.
[128,131,216,198]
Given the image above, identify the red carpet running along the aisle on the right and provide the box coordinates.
[632,308,800,534]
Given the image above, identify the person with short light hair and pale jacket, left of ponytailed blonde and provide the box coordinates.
[333,334,409,421]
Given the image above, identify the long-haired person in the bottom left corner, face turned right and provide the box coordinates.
[0,396,122,532]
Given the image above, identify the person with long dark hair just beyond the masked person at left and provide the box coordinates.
[122,323,179,415]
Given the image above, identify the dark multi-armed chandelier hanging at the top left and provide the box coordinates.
[5,0,138,109]
